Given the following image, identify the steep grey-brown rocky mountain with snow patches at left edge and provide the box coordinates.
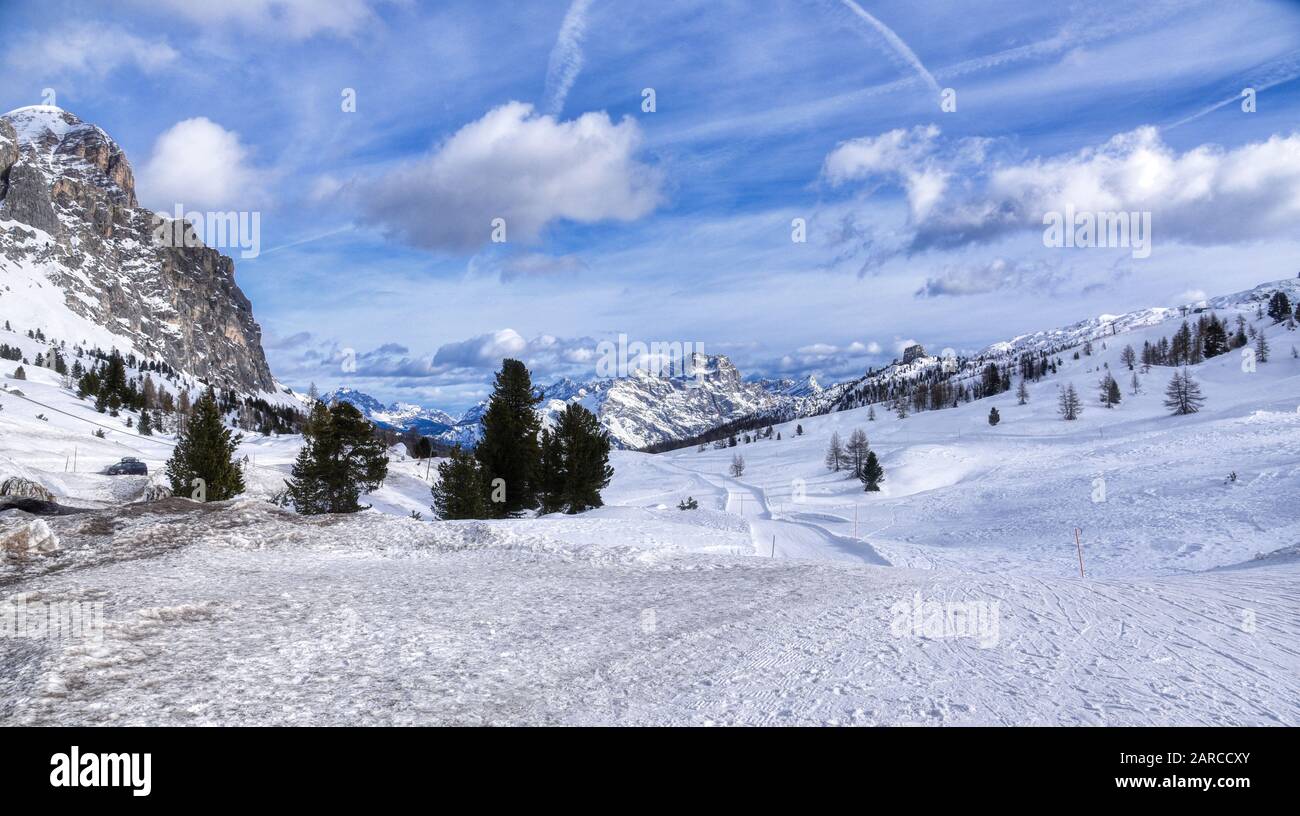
[0,105,278,394]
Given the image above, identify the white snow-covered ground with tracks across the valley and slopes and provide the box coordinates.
[0,296,1300,725]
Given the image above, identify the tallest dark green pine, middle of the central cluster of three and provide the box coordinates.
[475,360,541,518]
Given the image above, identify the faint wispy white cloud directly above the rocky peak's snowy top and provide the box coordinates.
[8,22,179,75]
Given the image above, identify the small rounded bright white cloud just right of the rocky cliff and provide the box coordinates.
[140,117,264,213]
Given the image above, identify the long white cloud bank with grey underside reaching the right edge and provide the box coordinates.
[823,126,1300,265]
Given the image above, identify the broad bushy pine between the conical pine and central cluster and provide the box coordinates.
[285,400,389,516]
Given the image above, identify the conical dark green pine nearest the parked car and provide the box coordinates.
[166,389,244,502]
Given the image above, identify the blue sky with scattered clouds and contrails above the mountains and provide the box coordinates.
[0,0,1300,411]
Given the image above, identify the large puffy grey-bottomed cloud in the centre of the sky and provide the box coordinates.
[359,103,662,249]
